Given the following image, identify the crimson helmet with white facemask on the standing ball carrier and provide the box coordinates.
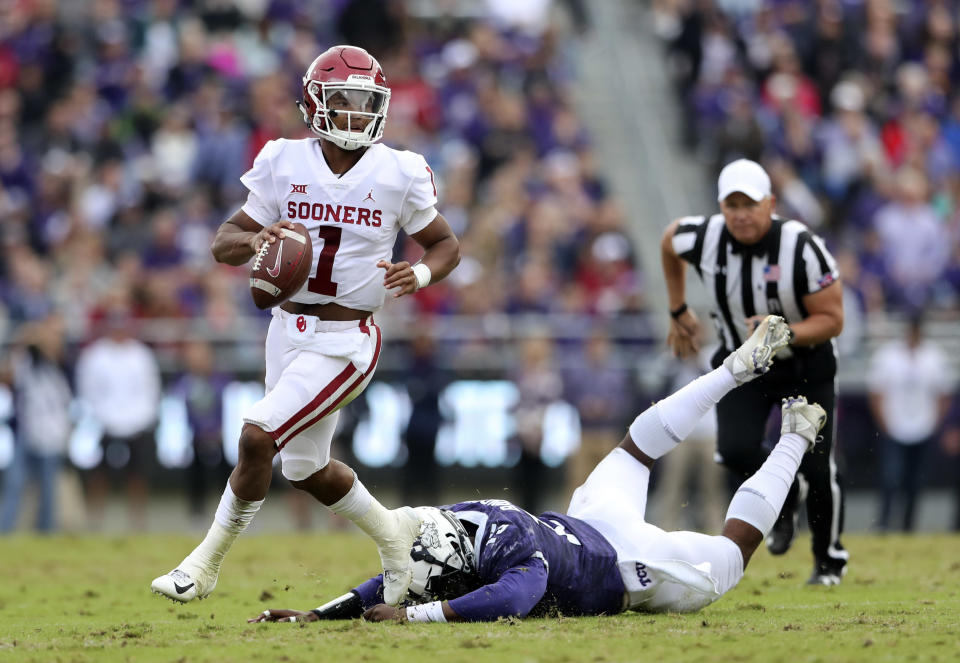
[297,46,390,150]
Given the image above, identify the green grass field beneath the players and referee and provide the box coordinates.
[0,534,960,663]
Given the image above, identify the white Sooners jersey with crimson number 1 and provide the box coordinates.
[240,138,437,311]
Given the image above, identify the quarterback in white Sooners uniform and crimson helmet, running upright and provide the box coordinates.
[151,46,460,603]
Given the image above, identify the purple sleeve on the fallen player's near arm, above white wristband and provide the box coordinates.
[449,557,547,622]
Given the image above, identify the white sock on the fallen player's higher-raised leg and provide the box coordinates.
[630,366,737,459]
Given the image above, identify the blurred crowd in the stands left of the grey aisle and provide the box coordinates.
[0,0,642,338]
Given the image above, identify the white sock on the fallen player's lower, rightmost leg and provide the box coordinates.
[727,433,809,538]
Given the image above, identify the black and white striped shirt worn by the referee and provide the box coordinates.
[673,213,839,352]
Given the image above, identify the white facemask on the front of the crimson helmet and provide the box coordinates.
[300,74,390,150]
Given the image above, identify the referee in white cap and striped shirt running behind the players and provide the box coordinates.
[661,159,849,585]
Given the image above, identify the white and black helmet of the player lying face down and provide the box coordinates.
[407,506,480,603]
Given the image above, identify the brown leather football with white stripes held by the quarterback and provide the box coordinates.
[250,223,313,309]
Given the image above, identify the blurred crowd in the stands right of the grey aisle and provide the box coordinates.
[654,0,960,318]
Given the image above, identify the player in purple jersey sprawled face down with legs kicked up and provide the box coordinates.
[250,316,826,622]
